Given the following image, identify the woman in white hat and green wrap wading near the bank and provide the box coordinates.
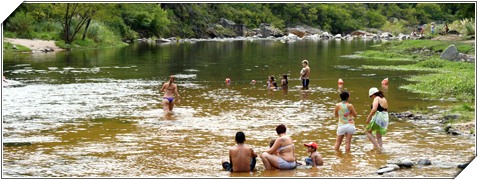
[365,87,388,149]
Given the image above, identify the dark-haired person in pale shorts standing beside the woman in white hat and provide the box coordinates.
[334,91,357,152]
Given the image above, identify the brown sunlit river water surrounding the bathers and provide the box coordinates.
[2,40,475,177]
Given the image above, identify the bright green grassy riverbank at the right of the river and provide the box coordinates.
[357,36,476,136]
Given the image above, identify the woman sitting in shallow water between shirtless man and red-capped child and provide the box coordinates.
[261,124,297,169]
